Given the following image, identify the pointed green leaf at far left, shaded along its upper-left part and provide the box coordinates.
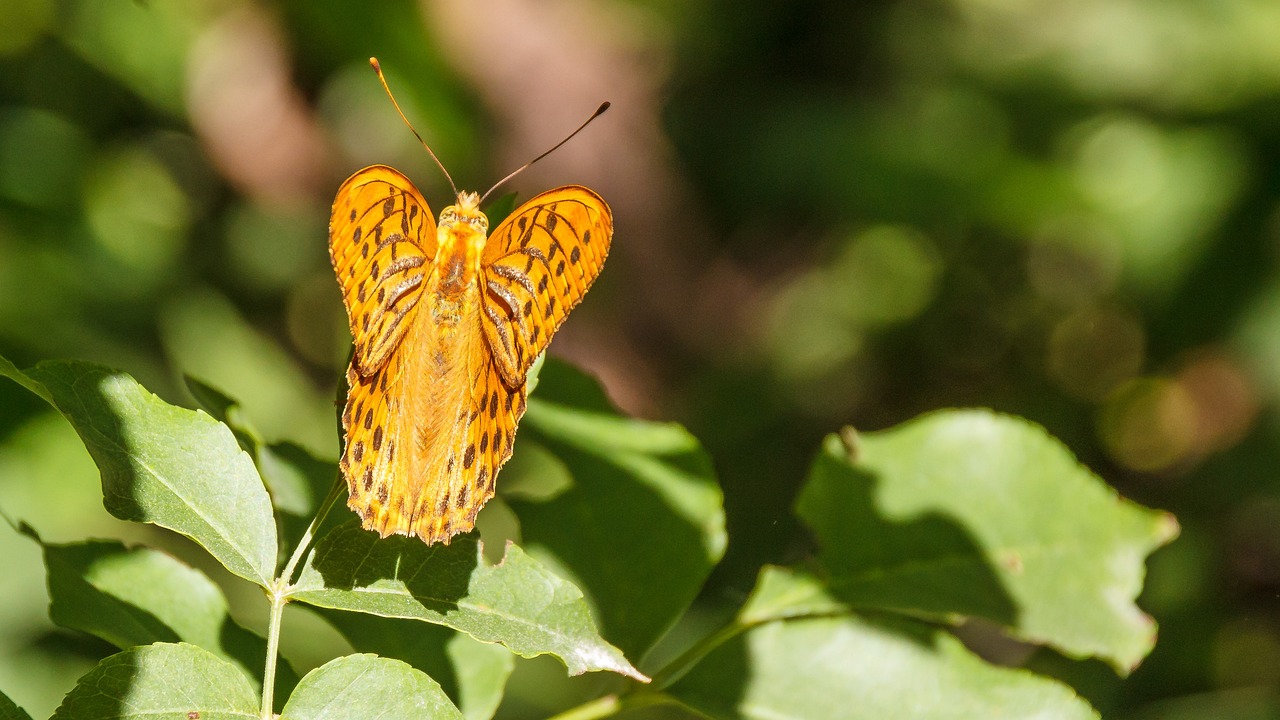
[0,361,276,587]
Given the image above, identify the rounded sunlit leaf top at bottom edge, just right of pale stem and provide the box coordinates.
[280,655,462,720]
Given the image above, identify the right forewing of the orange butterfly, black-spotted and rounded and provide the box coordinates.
[480,186,613,387]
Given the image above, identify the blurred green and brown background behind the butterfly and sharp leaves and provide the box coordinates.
[0,0,1280,719]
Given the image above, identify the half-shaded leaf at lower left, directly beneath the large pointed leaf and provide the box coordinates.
[36,538,298,697]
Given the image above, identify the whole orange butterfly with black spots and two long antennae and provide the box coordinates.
[329,59,613,544]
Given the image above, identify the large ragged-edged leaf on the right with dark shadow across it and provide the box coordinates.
[797,411,1178,673]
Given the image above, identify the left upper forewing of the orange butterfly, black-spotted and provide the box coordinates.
[329,165,435,377]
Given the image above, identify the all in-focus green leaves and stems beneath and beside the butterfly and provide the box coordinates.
[0,359,1176,720]
